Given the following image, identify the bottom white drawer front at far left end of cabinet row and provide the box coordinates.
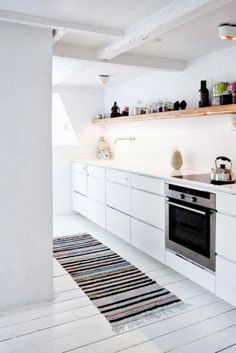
[73,192,106,228]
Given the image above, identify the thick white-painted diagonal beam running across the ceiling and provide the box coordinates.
[96,0,232,60]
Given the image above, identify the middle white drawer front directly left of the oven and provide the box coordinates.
[131,189,165,230]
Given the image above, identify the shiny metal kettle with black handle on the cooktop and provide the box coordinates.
[211,156,236,185]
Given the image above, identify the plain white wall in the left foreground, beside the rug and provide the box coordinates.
[0,22,52,311]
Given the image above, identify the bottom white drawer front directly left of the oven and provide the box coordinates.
[131,219,165,263]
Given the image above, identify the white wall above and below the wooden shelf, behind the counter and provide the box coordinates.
[105,47,236,170]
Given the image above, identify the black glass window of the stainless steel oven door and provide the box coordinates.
[169,205,210,258]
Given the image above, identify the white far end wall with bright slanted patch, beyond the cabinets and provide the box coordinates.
[52,87,104,216]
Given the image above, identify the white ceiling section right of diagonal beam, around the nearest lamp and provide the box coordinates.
[130,0,236,61]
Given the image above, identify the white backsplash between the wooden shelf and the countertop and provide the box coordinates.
[105,116,236,171]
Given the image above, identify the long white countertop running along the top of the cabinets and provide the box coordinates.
[73,159,236,194]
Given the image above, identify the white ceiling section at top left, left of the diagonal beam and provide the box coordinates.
[0,0,173,30]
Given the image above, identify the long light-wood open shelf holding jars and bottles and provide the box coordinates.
[93,104,236,125]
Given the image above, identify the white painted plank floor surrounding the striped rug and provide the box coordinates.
[0,215,236,353]
